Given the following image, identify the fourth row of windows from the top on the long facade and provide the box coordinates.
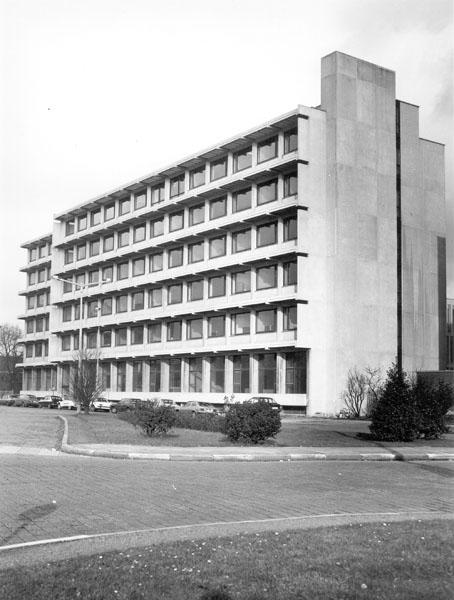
[62,260,298,322]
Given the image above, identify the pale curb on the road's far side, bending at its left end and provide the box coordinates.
[58,415,454,462]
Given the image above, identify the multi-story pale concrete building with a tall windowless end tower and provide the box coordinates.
[17,52,446,414]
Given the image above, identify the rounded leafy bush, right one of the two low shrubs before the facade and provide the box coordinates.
[225,401,281,444]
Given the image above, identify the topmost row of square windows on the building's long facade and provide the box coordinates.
[65,129,298,236]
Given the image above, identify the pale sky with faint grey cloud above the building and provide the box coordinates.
[0,0,454,323]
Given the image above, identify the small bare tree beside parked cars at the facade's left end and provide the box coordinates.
[70,348,104,414]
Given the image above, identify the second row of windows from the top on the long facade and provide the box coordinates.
[64,176,296,264]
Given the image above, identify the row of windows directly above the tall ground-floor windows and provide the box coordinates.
[61,306,297,351]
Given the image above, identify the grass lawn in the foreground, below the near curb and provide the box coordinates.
[0,521,454,600]
